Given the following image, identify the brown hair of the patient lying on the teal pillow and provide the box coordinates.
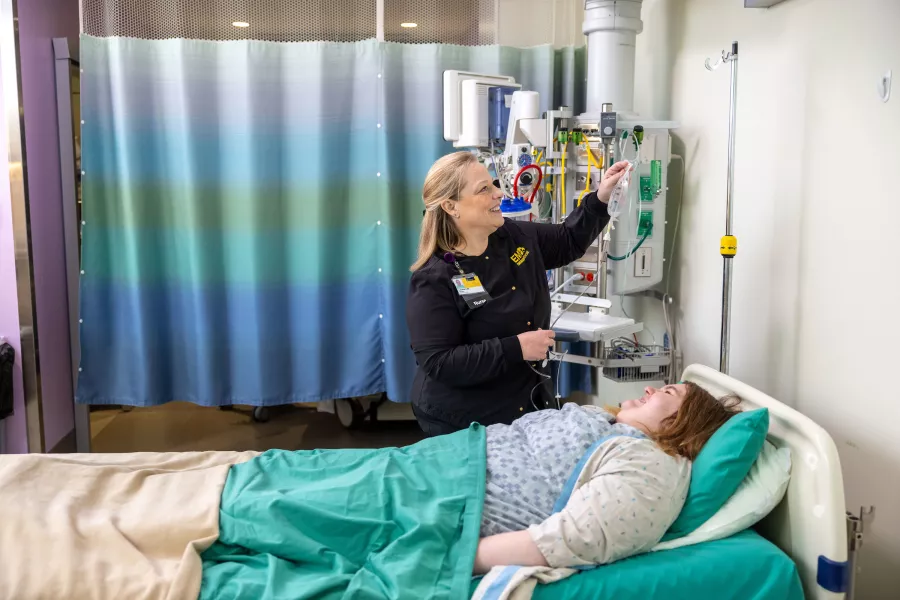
[606,381,741,460]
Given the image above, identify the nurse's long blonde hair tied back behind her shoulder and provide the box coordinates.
[409,151,478,271]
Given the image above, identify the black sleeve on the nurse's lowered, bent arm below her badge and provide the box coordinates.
[406,267,523,387]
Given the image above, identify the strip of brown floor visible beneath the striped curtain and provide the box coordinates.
[91,402,423,452]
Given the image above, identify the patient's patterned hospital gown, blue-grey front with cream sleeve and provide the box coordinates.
[481,404,690,566]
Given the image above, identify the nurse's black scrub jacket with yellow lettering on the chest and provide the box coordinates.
[406,193,609,434]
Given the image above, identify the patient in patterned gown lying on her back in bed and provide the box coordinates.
[474,383,737,574]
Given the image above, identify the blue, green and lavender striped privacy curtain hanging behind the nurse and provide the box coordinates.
[77,36,583,406]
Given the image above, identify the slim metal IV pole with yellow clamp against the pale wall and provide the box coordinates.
[706,42,738,375]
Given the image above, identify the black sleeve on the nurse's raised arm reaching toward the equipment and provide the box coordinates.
[515,192,609,269]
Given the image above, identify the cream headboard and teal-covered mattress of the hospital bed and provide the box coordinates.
[473,365,852,600]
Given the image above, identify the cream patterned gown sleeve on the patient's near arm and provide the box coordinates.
[528,438,690,567]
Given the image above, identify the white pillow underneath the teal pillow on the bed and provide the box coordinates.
[653,441,791,551]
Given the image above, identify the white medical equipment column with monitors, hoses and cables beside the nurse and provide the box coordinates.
[443,0,676,382]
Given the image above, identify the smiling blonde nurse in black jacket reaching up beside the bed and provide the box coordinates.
[406,152,628,436]
